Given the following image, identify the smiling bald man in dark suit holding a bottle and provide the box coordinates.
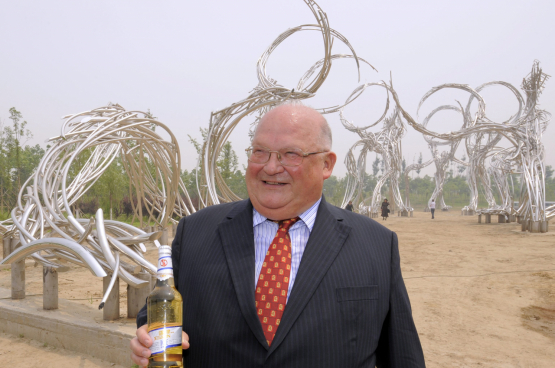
[131,104,424,368]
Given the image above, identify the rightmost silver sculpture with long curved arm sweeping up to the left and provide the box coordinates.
[394,61,553,231]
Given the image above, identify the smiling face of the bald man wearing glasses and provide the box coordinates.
[245,106,336,220]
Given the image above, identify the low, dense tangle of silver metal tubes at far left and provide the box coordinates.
[1,104,194,305]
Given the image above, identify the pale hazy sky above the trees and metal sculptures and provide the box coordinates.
[0,0,555,176]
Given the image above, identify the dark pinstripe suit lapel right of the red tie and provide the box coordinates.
[267,197,351,357]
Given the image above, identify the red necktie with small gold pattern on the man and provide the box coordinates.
[255,217,299,346]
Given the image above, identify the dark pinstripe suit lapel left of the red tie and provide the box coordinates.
[218,201,268,347]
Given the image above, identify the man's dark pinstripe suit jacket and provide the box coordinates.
[137,200,424,368]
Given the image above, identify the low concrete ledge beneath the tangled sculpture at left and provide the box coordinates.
[0,288,136,367]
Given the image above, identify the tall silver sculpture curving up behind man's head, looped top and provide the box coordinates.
[196,0,371,207]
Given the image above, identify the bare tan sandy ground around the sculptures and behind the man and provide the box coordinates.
[0,210,555,368]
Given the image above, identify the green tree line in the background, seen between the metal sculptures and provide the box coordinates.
[0,107,555,221]
